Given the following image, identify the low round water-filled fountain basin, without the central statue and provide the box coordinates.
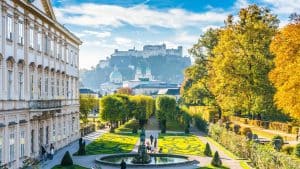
[96,154,195,167]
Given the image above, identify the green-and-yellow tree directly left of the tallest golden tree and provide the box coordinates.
[180,29,220,107]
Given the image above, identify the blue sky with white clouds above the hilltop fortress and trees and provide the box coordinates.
[52,0,300,69]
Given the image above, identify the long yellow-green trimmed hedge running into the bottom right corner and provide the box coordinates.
[209,124,300,169]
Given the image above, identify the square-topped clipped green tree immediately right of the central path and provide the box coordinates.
[156,96,176,133]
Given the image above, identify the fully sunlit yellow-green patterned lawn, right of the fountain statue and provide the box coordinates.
[158,134,205,156]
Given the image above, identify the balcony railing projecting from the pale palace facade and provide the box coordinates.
[29,100,62,109]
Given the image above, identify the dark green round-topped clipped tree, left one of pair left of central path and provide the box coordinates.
[100,95,124,132]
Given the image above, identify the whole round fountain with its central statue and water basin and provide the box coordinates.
[96,129,195,168]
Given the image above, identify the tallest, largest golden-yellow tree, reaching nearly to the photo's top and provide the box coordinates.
[209,5,278,117]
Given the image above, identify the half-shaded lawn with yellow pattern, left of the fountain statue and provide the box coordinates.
[86,133,138,155]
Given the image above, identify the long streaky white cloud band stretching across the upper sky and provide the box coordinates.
[55,3,228,29]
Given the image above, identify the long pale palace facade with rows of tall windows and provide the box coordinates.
[0,0,82,168]
